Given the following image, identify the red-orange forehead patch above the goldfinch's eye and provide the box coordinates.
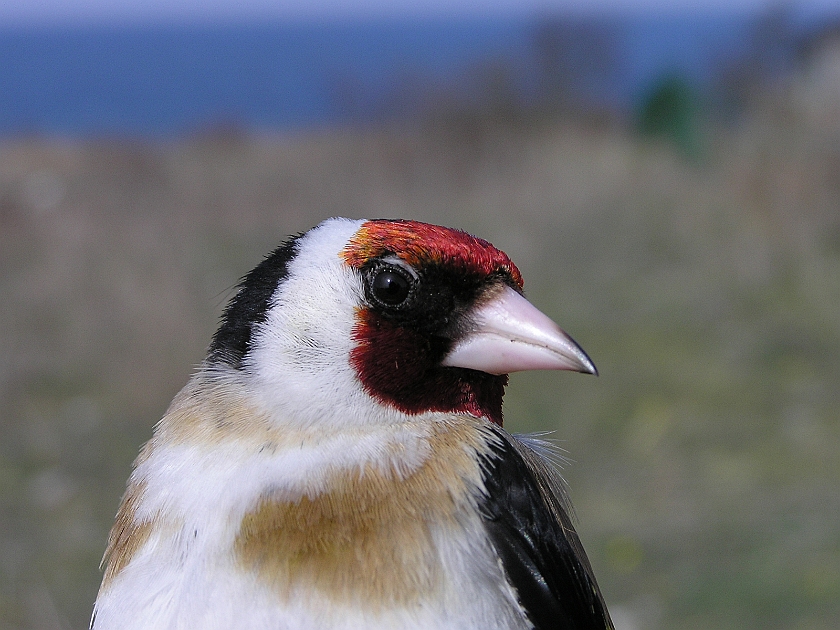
[342,219,522,288]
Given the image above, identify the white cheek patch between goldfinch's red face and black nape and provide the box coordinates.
[244,219,406,428]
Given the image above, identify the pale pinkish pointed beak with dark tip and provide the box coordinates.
[443,286,598,375]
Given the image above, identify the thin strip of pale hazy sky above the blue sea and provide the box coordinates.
[0,0,837,25]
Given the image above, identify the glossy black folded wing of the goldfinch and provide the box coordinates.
[482,426,613,630]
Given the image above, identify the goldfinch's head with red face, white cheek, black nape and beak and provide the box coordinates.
[207,219,596,424]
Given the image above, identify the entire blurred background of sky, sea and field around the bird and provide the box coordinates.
[0,0,840,630]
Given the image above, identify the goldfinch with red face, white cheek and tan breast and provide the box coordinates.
[90,218,613,630]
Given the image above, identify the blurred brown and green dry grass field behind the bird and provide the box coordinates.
[0,106,840,630]
